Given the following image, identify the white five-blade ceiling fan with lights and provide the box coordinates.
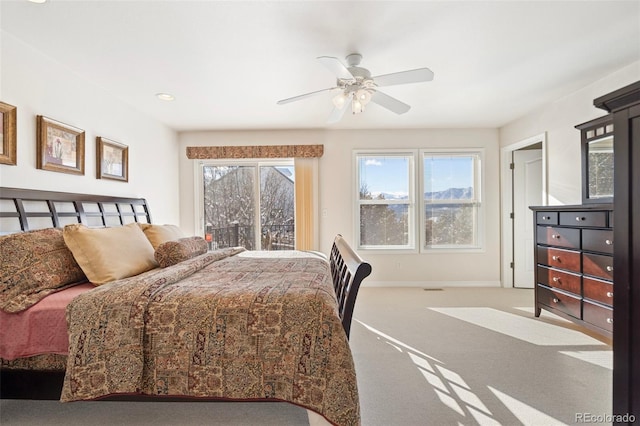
[277,53,433,123]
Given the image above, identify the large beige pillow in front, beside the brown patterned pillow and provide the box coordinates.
[62,223,158,285]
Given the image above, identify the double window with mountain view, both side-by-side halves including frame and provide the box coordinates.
[355,150,482,252]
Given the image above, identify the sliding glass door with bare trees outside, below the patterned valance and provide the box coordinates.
[202,161,295,250]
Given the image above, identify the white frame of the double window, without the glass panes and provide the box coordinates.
[352,148,485,254]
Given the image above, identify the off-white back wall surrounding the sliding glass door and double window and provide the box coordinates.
[180,129,500,287]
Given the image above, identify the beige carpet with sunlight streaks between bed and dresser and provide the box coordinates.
[353,288,613,426]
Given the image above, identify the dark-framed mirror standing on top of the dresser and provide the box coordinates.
[576,115,614,203]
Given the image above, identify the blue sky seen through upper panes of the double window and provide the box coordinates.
[360,156,473,195]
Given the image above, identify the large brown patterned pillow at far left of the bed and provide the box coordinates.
[0,228,86,312]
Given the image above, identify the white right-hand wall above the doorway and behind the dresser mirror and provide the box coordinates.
[500,62,640,205]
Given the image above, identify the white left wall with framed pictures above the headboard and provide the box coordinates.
[0,32,180,223]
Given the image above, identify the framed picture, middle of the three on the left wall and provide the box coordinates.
[36,115,84,175]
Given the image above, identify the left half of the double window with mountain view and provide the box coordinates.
[356,153,415,249]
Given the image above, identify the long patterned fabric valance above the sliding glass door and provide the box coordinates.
[187,145,324,160]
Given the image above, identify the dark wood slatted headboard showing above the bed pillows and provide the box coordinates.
[0,188,151,234]
